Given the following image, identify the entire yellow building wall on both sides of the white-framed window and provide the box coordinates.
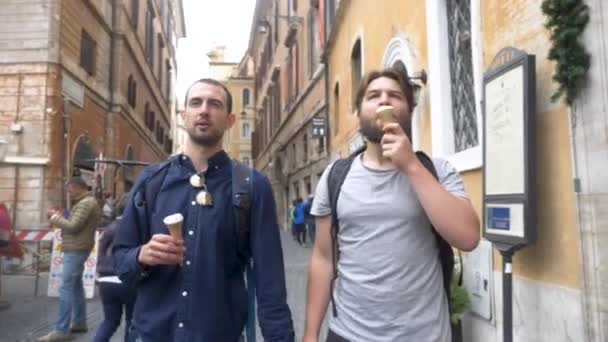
[328,0,581,288]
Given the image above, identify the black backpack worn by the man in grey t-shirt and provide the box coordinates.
[327,147,454,316]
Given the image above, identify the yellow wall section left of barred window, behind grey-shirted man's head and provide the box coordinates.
[328,0,430,156]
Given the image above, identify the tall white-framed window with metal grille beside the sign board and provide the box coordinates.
[426,0,483,171]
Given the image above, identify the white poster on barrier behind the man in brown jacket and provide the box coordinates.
[47,229,100,299]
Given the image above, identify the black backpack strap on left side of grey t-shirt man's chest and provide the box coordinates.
[327,154,356,317]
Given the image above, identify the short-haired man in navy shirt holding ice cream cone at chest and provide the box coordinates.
[113,79,294,342]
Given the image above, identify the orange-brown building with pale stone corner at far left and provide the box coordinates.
[0,0,185,229]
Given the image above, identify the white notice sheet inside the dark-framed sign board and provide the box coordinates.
[485,65,525,195]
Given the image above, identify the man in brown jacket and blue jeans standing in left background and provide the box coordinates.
[37,177,100,342]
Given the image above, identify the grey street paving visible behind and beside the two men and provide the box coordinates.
[0,232,311,342]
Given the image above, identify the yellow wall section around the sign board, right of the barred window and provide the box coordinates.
[481,0,581,288]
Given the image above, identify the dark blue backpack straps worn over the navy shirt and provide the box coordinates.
[135,156,256,342]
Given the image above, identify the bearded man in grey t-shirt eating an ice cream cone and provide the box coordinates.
[304,68,479,342]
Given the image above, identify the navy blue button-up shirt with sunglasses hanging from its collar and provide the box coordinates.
[113,151,294,342]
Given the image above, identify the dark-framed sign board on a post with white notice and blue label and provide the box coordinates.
[483,48,536,250]
